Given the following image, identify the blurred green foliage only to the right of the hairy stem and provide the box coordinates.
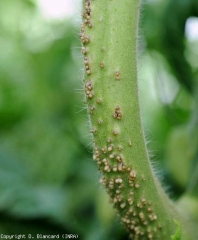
[142,0,198,198]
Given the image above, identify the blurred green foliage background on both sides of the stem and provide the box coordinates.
[0,0,198,240]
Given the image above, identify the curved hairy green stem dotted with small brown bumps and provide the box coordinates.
[80,0,193,240]
